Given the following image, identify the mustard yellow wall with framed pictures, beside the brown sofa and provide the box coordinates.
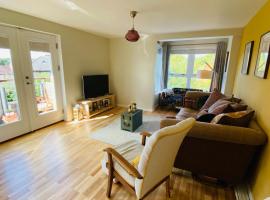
[234,1,270,200]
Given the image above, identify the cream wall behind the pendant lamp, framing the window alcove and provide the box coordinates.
[110,29,242,110]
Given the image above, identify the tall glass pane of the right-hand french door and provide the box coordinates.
[29,42,56,114]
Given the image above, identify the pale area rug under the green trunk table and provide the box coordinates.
[90,115,161,145]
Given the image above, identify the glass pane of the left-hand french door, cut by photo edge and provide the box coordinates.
[0,37,20,125]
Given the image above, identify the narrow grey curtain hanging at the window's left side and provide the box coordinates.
[162,42,170,89]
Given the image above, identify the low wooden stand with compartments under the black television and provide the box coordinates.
[78,94,115,119]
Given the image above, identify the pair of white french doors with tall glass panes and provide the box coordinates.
[0,26,63,141]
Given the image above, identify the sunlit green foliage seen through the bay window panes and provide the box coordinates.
[168,54,215,91]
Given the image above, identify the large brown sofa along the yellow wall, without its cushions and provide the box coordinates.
[160,92,266,184]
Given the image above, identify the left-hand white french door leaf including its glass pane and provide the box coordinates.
[0,25,31,142]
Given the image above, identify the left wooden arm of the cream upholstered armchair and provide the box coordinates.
[104,148,143,179]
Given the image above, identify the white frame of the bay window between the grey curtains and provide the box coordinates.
[168,44,217,88]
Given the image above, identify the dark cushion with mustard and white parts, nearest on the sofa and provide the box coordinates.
[211,110,255,127]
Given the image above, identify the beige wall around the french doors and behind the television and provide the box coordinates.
[0,8,109,120]
